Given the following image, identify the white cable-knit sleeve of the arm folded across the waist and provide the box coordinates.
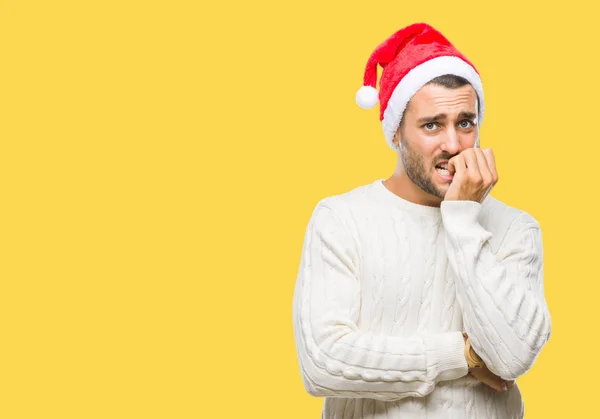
[293,201,468,401]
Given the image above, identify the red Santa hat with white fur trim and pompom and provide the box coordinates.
[356,23,484,149]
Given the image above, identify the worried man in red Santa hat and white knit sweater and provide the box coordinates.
[293,24,551,419]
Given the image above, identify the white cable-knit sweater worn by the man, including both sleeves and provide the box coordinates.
[293,179,551,419]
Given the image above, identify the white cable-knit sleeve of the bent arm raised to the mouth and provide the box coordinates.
[441,201,551,380]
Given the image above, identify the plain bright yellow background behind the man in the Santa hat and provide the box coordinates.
[0,0,600,419]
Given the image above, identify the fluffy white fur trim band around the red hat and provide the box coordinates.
[382,56,484,150]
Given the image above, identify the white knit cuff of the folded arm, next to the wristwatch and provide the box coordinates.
[424,332,469,381]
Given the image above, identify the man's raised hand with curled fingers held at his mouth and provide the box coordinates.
[444,147,498,203]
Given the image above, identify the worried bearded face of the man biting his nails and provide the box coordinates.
[394,84,479,199]
